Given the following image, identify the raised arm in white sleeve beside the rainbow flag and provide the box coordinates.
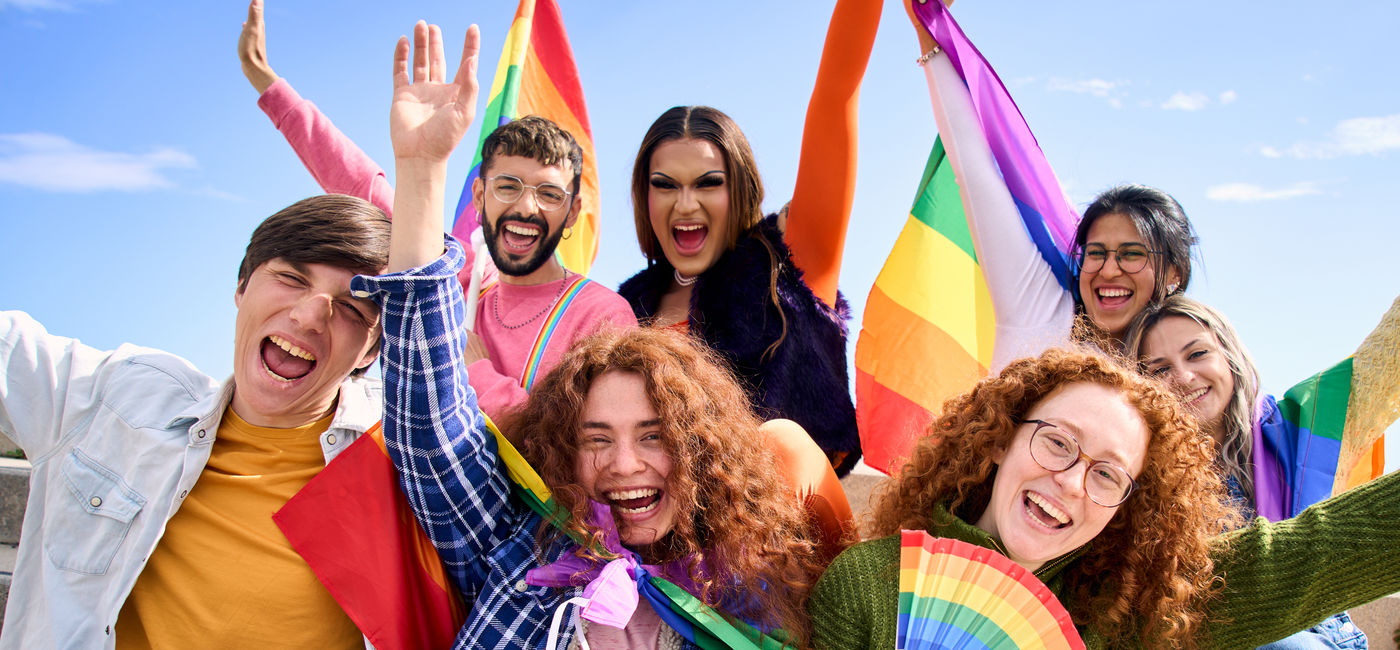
[904,0,1074,374]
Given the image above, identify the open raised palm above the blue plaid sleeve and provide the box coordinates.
[392,22,482,163]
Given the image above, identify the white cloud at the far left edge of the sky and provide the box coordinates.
[0,133,197,192]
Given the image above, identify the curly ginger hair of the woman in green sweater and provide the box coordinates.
[871,349,1239,647]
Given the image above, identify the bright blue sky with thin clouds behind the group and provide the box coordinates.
[0,0,1400,468]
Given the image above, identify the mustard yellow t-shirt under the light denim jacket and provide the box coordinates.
[116,408,364,649]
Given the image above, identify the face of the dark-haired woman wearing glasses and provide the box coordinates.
[1079,213,1177,340]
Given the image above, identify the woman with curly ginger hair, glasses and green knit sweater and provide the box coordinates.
[811,349,1400,650]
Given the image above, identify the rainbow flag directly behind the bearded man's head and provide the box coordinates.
[452,0,601,275]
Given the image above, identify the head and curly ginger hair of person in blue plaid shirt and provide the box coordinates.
[503,329,825,647]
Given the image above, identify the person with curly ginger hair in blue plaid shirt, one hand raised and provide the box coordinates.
[353,21,829,650]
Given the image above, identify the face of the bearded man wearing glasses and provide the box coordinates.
[472,155,582,284]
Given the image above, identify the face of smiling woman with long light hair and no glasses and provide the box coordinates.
[1141,317,1235,440]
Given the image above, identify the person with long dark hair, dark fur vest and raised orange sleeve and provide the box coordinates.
[617,0,881,475]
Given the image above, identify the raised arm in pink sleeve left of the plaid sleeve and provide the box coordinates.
[238,0,393,213]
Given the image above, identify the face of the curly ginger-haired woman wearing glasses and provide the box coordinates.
[977,382,1148,570]
